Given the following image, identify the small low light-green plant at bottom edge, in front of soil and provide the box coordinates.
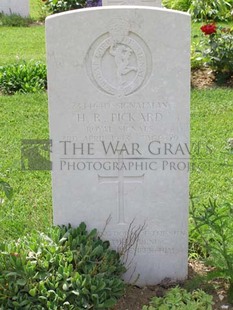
[142,286,212,310]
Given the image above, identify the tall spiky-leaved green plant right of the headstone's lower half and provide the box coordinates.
[190,200,233,302]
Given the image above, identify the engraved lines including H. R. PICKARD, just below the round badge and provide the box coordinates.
[72,97,170,142]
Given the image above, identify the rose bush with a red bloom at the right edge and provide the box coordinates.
[201,23,233,80]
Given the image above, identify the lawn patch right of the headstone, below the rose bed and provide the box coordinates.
[190,88,233,203]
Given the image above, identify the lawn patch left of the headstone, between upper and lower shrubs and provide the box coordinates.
[0,93,52,240]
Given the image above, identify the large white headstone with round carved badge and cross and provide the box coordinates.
[46,6,190,285]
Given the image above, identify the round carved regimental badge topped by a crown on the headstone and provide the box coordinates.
[86,19,152,96]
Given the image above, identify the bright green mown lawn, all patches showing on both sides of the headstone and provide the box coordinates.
[0,17,233,240]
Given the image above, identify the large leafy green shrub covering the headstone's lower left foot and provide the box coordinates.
[0,223,125,310]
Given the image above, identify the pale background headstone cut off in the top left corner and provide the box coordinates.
[0,0,29,17]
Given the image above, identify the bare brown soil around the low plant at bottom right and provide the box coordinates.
[113,260,233,310]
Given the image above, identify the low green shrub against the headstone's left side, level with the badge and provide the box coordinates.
[0,62,47,95]
